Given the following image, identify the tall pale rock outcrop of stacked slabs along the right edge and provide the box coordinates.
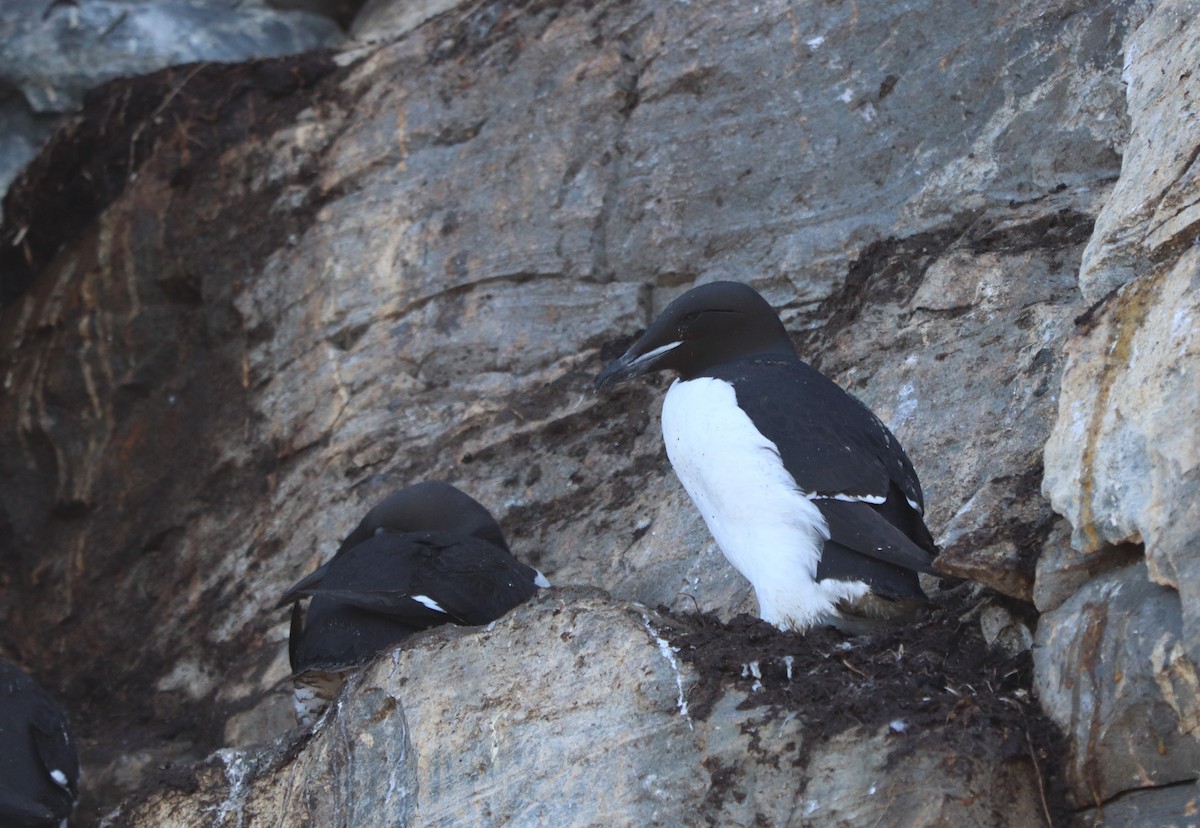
[1039,2,1200,691]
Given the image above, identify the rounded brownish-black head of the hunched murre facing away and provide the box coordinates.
[337,480,510,552]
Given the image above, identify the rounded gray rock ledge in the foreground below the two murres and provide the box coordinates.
[120,589,1040,827]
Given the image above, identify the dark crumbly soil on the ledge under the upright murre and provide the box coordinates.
[659,588,1072,826]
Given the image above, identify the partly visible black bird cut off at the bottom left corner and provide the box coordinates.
[0,660,79,828]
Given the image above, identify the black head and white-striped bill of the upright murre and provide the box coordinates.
[595,282,796,389]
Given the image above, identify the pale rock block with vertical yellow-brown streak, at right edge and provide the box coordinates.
[1044,244,1200,571]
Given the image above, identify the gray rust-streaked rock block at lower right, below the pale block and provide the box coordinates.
[1033,564,1200,806]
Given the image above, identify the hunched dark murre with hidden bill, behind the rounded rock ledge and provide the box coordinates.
[277,480,550,724]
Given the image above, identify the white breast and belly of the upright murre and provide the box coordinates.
[662,377,868,629]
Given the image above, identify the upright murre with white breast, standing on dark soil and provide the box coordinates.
[595,282,937,631]
